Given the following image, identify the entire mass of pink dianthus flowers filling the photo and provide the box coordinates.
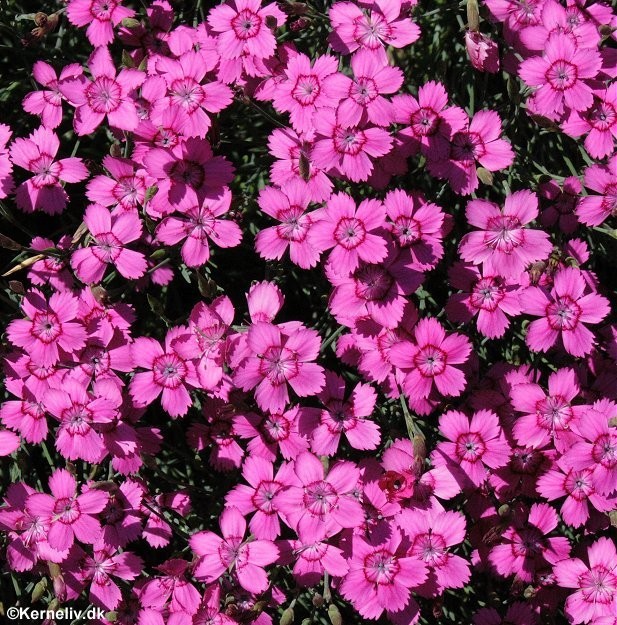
[0,0,617,625]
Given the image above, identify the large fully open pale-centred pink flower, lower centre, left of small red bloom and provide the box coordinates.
[274,451,364,541]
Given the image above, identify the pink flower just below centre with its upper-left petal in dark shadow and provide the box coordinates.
[307,371,381,456]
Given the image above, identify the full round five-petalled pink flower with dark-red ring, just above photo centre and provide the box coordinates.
[309,193,388,275]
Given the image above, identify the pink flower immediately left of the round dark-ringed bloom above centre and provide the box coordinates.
[255,179,319,269]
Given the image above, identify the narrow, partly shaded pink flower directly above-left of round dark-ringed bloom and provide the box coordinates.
[268,128,332,202]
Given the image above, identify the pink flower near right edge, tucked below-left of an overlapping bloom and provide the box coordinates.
[536,456,617,527]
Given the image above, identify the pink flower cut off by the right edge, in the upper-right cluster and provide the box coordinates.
[561,83,617,158]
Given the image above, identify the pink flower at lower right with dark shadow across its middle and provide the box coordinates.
[489,503,570,583]
